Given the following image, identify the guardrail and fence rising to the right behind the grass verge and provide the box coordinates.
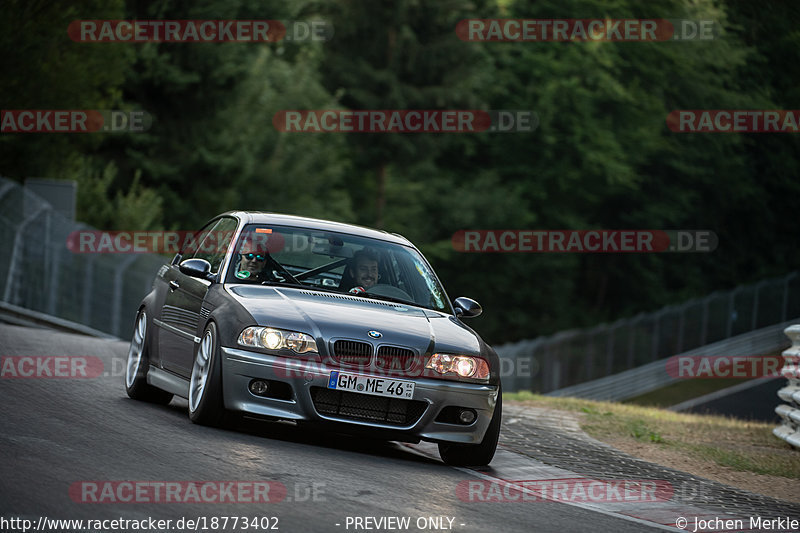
[495,272,800,393]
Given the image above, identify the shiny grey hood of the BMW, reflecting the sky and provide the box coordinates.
[229,285,481,355]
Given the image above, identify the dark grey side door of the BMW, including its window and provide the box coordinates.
[159,217,238,378]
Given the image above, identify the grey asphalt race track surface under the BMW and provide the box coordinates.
[0,324,676,533]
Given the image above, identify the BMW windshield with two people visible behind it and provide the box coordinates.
[225,224,450,313]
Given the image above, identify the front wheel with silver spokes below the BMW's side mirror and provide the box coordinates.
[189,322,226,427]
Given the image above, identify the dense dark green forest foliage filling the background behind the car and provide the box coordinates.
[0,0,800,342]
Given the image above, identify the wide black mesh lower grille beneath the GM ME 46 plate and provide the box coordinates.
[311,387,427,426]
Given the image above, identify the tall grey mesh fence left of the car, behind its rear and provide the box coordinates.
[0,178,168,339]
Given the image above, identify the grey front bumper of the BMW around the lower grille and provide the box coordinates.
[222,347,498,444]
